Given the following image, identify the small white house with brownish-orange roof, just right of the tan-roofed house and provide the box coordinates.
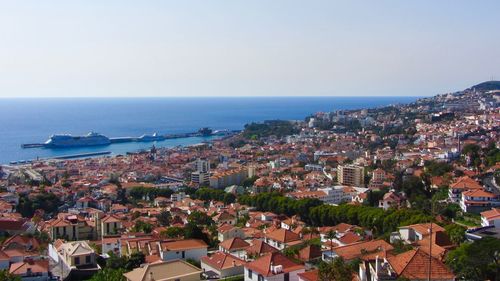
[201,251,245,279]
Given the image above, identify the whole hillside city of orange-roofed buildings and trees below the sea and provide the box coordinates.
[0,81,500,281]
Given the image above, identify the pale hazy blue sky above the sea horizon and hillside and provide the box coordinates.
[0,0,500,97]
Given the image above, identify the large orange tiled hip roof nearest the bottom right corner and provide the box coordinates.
[387,249,455,280]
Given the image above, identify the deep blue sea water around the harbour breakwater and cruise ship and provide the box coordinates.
[0,97,417,164]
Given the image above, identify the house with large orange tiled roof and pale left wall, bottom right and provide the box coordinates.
[359,249,455,281]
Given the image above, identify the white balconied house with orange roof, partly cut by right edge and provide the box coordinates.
[460,189,500,213]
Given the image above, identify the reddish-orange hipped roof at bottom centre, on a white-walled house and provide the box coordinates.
[245,252,305,276]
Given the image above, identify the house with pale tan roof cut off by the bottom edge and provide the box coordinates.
[123,260,202,281]
